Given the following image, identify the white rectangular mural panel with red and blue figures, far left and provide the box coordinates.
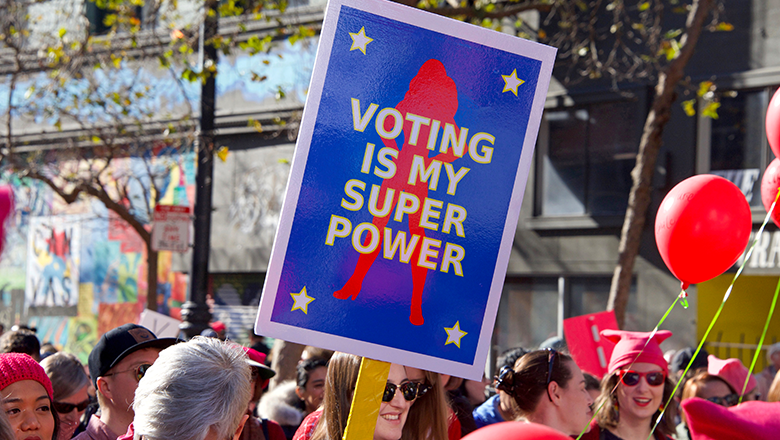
[25,216,81,307]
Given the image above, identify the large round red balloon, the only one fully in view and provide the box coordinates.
[655,174,752,289]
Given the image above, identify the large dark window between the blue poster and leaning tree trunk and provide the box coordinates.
[536,100,644,216]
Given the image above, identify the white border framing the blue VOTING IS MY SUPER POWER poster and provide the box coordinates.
[255,0,556,380]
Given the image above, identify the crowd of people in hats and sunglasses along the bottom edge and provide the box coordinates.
[0,324,780,440]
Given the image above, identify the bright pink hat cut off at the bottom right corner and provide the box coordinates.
[682,397,780,440]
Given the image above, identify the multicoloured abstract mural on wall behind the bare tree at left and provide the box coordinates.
[0,150,195,362]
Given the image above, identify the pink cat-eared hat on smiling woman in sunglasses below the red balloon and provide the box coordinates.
[601,330,672,374]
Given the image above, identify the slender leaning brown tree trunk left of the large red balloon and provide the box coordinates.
[607,0,712,328]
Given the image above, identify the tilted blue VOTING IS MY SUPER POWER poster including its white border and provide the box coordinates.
[256,0,555,377]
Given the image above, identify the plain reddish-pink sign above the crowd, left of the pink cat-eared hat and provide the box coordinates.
[563,310,618,379]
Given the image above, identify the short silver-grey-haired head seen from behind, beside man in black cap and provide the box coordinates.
[125,336,252,440]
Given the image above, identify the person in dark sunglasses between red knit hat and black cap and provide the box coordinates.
[41,352,89,440]
